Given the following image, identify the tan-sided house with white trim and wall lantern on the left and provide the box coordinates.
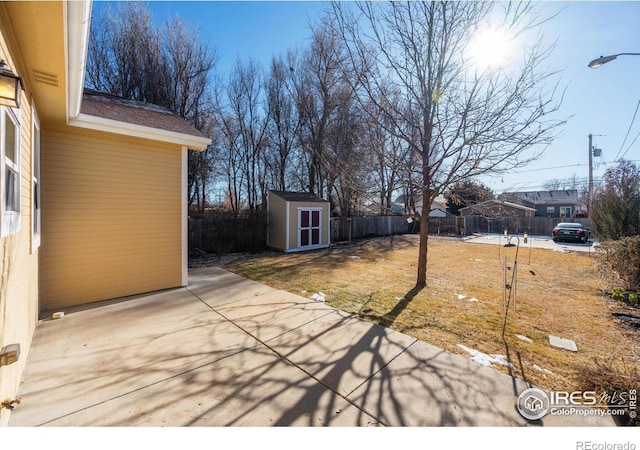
[0,1,210,426]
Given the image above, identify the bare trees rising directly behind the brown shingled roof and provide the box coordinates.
[86,2,216,210]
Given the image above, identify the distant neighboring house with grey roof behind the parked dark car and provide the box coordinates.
[500,190,582,218]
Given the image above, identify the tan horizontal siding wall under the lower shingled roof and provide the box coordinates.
[41,126,183,309]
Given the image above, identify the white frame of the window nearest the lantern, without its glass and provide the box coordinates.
[0,106,22,237]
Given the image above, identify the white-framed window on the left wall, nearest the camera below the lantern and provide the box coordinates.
[0,106,22,237]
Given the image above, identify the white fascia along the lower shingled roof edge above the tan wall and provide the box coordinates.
[69,113,211,150]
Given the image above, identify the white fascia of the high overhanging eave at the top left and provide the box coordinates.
[65,0,92,121]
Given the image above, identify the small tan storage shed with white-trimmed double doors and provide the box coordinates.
[267,191,331,253]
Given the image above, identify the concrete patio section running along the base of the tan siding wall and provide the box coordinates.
[12,289,258,426]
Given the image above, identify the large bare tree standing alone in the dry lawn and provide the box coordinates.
[328,1,563,288]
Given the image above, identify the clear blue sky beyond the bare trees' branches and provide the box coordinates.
[94,1,640,193]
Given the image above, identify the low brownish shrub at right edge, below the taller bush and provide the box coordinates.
[596,236,640,291]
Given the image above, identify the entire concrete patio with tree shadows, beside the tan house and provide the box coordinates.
[9,269,614,427]
